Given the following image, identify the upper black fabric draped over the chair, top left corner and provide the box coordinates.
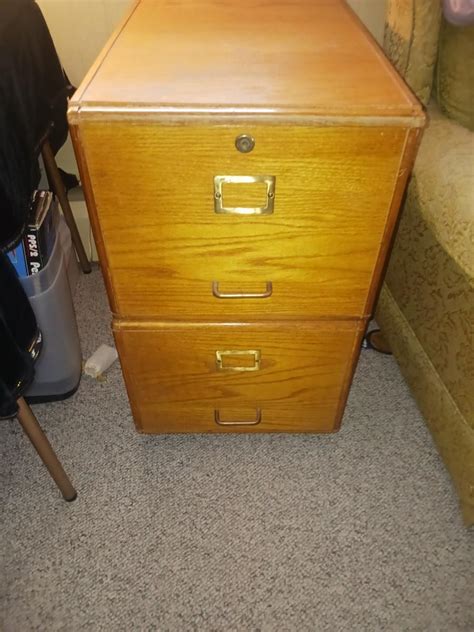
[0,0,74,251]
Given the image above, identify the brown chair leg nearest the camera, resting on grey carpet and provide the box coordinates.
[17,397,77,501]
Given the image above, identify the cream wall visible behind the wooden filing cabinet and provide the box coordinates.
[37,0,386,259]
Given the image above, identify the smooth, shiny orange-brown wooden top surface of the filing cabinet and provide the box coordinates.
[71,0,422,118]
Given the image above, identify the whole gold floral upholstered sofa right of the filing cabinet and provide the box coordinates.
[376,0,474,525]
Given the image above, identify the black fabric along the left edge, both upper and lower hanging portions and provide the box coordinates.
[0,0,73,418]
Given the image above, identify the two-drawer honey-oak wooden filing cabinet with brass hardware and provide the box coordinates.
[69,0,424,432]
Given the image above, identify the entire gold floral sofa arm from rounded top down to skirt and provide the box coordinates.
[376,105,474,524]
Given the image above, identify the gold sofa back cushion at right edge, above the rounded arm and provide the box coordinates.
[436,20,474,131]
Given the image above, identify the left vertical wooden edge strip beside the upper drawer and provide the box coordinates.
[69,125,117,312]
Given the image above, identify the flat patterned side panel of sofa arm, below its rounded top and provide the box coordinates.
[384,193,474,429]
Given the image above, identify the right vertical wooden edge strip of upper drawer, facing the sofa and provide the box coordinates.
[365,129,423,315]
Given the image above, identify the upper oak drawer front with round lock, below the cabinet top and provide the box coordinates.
[80,121,406,319]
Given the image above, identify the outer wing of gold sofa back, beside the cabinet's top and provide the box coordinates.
[384,0,441,105]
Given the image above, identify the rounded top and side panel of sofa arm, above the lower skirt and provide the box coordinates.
[385,102,474,427]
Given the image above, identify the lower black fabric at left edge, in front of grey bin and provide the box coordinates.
[0,252,38,419]
